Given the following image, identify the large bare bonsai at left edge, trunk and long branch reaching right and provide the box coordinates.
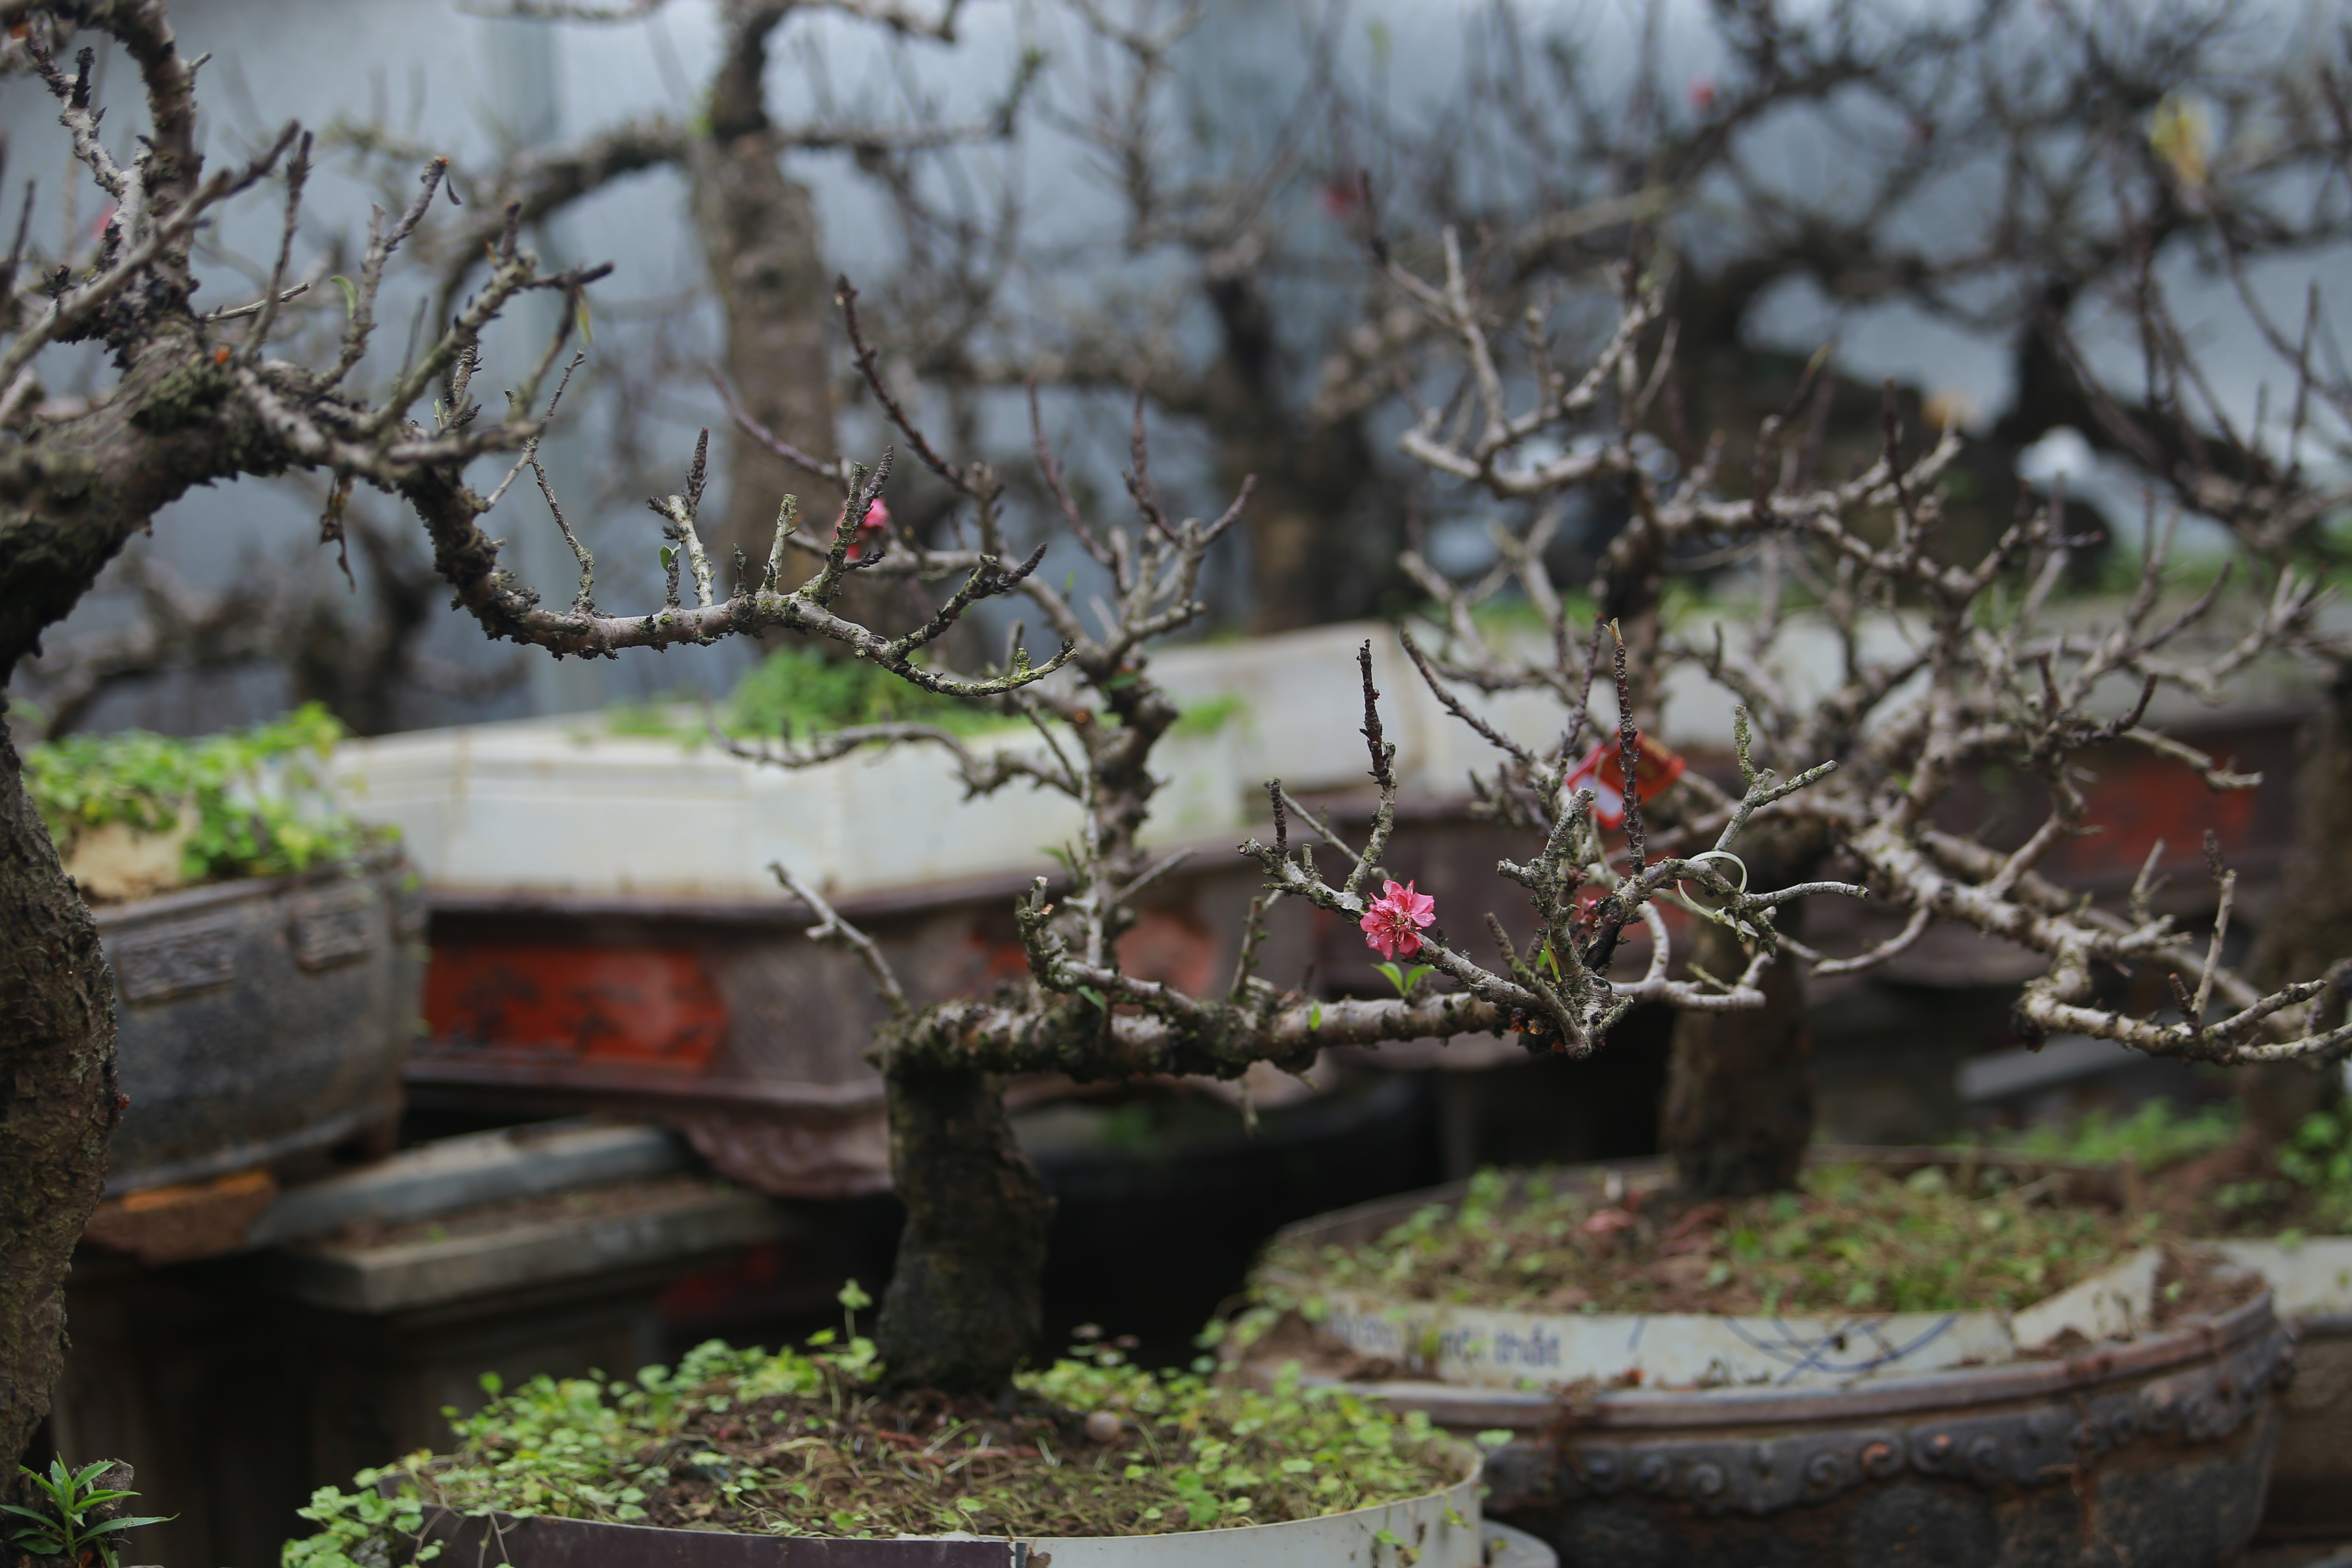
[0,0,1068,1485]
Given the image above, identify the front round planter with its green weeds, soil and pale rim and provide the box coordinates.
[285,1335,1477,1568]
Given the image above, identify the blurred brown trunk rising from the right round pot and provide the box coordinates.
[1660,823,1820,1197]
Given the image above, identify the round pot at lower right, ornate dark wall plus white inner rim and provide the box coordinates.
[1244,1152,2296,1568]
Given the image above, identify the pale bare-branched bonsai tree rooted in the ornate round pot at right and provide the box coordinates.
[1364,230,2352,1197]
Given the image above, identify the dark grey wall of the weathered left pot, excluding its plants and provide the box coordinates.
[94,858,423,1194]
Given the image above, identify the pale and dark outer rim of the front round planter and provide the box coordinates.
[402,1462,1467,1568]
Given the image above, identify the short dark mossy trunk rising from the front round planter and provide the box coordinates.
[875,1063,1054,1394]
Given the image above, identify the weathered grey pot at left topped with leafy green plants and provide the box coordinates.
[24,705,426,1222]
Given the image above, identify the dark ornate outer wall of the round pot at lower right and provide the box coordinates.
[1249,1152,2296,1568]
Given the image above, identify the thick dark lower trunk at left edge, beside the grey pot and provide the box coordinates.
[0,724,118,1495]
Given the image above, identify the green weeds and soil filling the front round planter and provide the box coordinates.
[282,1326,1468,1568]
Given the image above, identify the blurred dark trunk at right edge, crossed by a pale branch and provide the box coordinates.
[2239,670,2352,1149]
